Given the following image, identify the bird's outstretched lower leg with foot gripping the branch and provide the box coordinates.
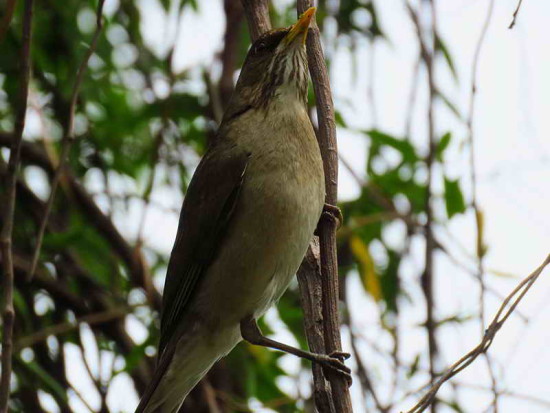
[241,317,351,384]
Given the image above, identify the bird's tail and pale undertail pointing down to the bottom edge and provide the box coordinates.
[136,331,240,413]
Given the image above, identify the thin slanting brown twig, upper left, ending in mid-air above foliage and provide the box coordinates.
[27,0,105,281]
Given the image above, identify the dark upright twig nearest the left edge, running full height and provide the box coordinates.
[0,0,33,413]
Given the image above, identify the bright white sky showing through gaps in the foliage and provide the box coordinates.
[31,0,550,413]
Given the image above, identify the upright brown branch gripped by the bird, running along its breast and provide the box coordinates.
[297,0,352,413]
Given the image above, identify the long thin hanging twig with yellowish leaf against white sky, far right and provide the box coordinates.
[466,0,502,413]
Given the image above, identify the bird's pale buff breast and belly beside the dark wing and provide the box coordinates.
[195,100,324,328]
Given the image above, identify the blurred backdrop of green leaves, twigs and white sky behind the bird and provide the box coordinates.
[0,0,550,412]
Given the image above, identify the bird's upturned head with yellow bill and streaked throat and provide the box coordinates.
[225,7,315,118]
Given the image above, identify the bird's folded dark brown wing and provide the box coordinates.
[158,139,250,356]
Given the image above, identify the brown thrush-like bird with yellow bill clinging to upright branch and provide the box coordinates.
[136,7,350,413]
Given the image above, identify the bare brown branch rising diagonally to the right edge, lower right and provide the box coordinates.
[407,254,550,413]
